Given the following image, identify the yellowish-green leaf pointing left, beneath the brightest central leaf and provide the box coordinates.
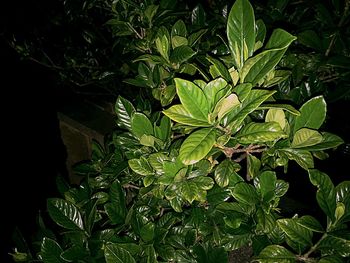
[163,104,210,127]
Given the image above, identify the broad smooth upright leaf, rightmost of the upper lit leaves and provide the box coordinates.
[294,96,327,132]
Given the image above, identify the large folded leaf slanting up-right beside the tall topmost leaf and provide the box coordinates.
[240,29,296,86]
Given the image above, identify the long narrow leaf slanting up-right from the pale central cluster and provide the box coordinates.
[226,90,275,132]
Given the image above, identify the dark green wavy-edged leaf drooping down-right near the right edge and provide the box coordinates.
[308,169,336,221]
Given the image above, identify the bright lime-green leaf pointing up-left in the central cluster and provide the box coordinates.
[175,78,209,122]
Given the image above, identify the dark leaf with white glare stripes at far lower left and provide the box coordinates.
[47,198,84,230]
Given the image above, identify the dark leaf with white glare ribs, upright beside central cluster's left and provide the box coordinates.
[114,96,135,130]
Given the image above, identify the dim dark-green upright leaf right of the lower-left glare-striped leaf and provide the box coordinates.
[104,181,126,225]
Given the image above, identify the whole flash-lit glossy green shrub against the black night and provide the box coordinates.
[10,0,350,263]
